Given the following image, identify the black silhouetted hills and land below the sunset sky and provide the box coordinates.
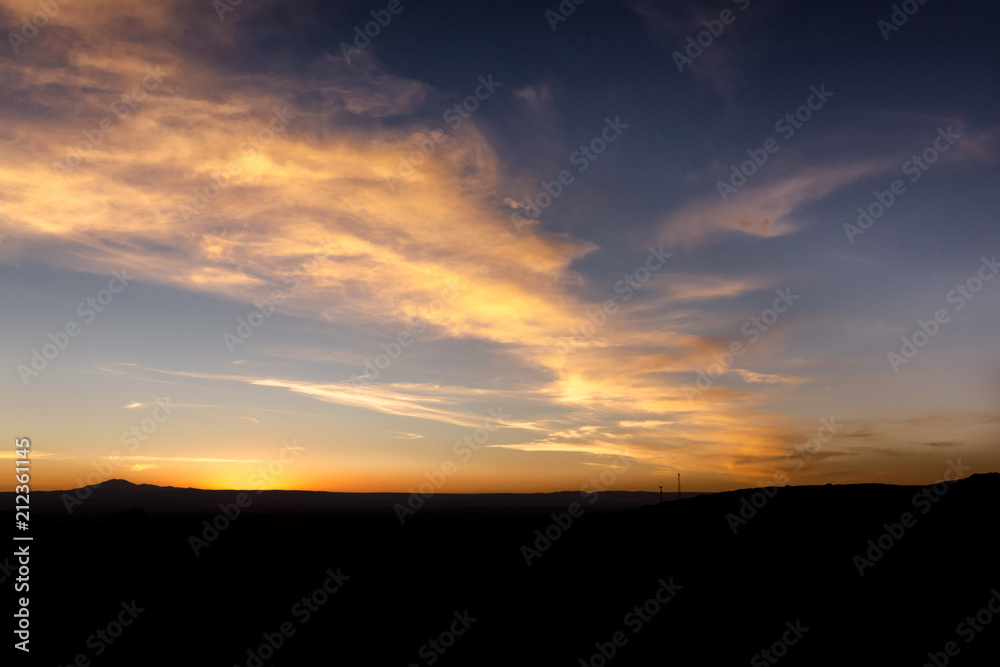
[0,473,1000,665]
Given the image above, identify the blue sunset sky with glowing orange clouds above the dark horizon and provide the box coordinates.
[0,0,1000,493]
